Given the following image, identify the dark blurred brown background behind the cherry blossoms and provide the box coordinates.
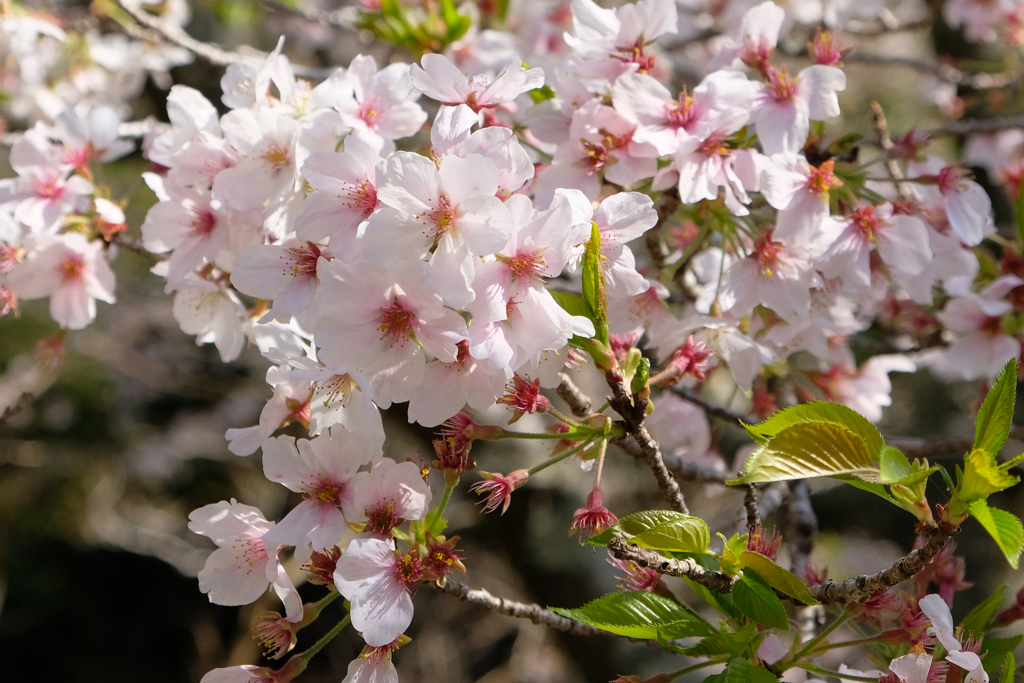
[0,0,1024,683]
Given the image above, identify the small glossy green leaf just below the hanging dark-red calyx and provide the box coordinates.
[586,510,711,553]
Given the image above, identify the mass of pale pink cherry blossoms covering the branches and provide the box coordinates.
[0,0,1024,683]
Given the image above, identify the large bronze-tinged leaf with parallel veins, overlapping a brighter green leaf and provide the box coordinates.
[727,422,881,485]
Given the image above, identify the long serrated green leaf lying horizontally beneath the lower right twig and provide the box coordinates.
[549,591,716,639]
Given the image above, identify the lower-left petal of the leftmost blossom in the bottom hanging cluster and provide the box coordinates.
[199,541,270,606]
